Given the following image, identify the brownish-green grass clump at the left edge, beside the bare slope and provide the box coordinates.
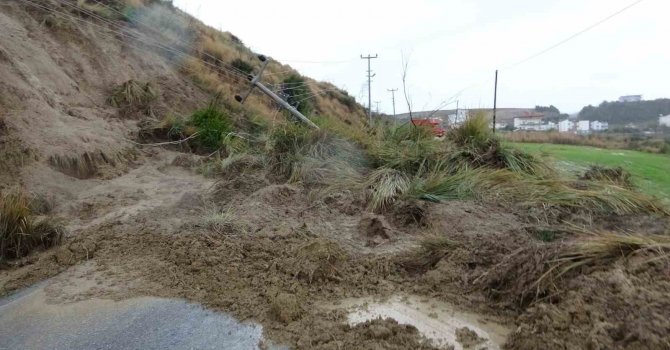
[0,191,64,262]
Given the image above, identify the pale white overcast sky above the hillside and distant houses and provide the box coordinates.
[174,0,670,113]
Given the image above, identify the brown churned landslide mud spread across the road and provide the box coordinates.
[0,152,670,349]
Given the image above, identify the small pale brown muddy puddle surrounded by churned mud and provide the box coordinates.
[331,296,510,350]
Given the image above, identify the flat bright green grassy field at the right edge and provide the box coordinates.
[514,143,670,202]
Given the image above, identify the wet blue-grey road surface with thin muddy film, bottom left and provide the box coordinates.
[0,286,286,350]
